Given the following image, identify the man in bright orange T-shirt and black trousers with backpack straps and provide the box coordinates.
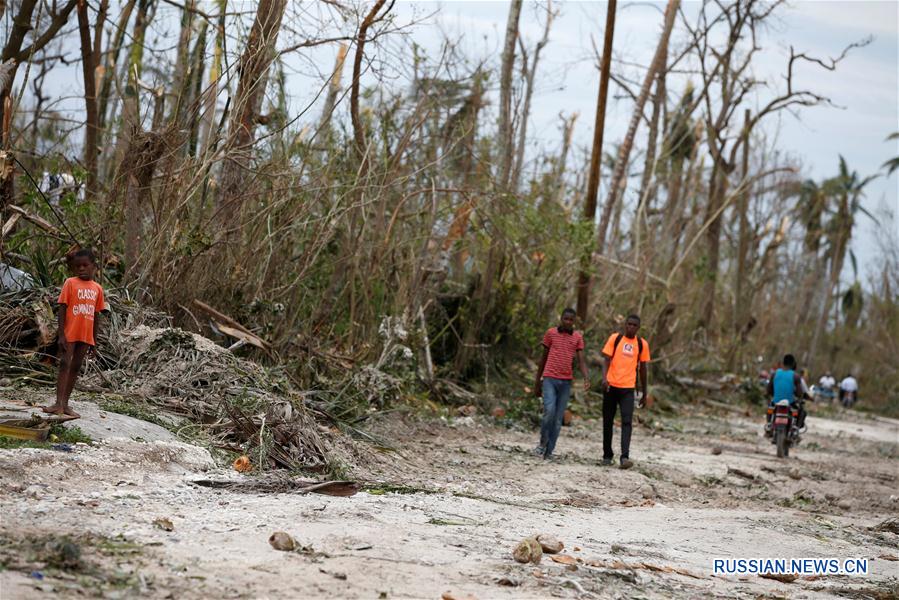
[602,315,650,469]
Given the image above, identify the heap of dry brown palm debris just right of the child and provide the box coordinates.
[85,325,328,470]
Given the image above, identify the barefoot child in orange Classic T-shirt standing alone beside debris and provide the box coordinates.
[42,249,106,419]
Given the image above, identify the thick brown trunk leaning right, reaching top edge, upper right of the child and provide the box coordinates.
[218,0,287,235]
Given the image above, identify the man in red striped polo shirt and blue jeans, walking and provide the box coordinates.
[534,308,590,460]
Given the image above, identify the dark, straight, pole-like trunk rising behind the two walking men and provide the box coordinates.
[577,0,616,327]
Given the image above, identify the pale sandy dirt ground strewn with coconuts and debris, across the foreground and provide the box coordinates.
[0,392,899,600]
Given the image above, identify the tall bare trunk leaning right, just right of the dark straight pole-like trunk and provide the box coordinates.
[596,0,680,255]
